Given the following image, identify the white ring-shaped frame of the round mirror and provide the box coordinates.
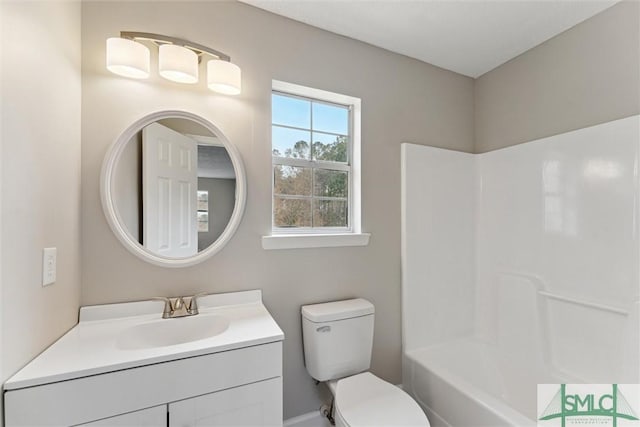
[100,110,247,268]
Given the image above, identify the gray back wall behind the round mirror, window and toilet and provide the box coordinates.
[82,1,474,418]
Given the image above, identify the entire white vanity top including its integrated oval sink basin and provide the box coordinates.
[0,290,284,394]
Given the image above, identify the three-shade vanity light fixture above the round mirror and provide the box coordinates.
[107,31,242,95]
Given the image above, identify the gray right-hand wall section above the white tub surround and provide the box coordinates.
[475,1,640,153]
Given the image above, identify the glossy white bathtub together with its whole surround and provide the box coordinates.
[403,116,640,425]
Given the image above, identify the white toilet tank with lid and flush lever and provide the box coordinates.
[302,298,374,381]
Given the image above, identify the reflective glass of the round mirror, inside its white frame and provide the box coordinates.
[112,118,236,259]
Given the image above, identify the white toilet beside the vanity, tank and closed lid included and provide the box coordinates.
[302,298,429,427]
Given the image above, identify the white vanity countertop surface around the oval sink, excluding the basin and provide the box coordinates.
[4,290,284,390]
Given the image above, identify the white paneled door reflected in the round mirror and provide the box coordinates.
[142,123,198,257]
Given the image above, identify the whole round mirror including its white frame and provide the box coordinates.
[101,111,246,267]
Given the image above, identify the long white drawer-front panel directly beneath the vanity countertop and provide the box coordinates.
[4,341,282,427]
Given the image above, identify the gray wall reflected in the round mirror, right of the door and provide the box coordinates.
[198,178,236,251]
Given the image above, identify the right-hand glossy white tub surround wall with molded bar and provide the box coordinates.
[476,116,640,383]
